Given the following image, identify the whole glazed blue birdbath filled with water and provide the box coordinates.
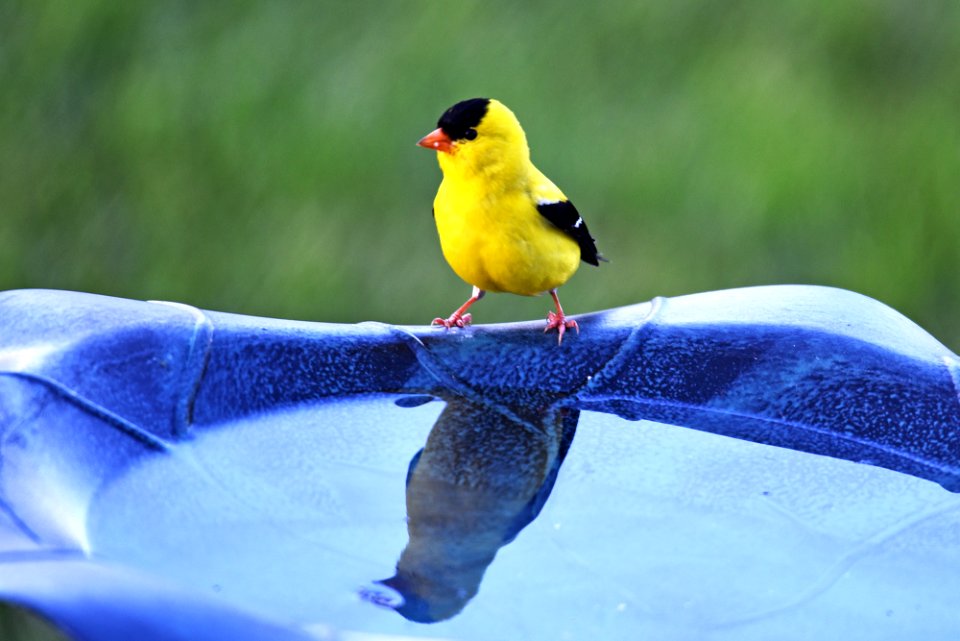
[0,286,960,641]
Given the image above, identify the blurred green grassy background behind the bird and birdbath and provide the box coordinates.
[0,0,960,350]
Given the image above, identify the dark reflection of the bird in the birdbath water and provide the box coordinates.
[372,398,579,623]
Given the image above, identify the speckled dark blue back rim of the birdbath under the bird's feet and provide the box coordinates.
[7,286,960,490]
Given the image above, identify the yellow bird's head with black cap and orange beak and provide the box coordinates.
[417,98,530,171]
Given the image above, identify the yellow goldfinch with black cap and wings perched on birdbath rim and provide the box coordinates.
[417,98,606,342]
